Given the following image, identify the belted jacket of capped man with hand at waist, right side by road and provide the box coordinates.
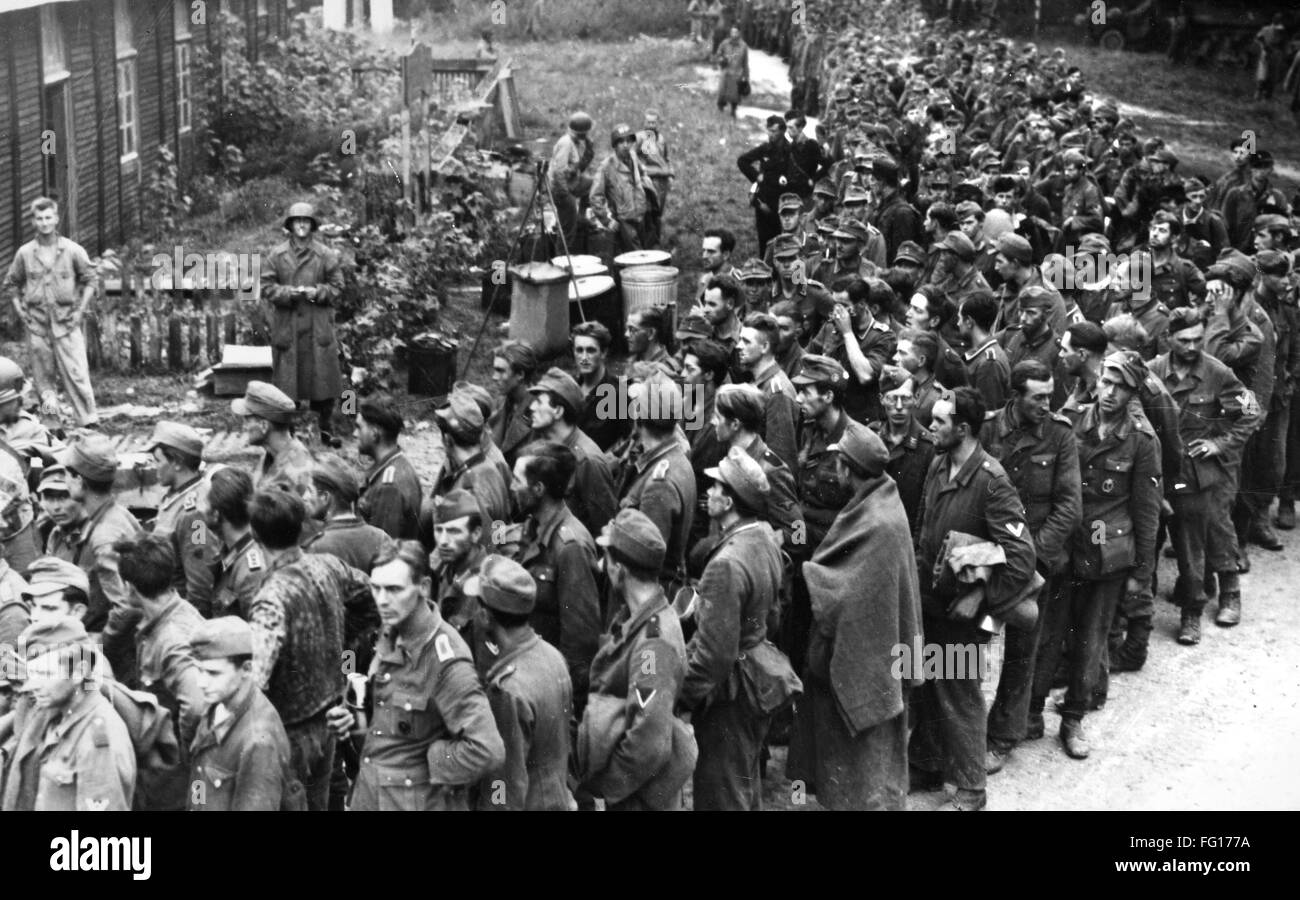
[1151,352,1260,493]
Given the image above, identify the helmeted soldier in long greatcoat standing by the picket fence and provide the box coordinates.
[261,203,343,445]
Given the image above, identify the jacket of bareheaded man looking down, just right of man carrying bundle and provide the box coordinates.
[979,401,1083,572]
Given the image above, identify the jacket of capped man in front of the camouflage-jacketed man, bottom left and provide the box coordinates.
[189,682,307,813]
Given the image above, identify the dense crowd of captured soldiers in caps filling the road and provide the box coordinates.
[0,3,1300,810]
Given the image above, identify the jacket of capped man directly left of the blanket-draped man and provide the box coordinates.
[679,520,784,710]
